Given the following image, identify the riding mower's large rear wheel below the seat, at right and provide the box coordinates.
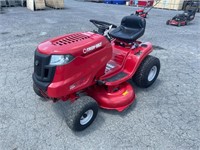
[132,55,160,88]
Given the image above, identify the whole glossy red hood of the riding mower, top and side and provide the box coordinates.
[34,32,112,98]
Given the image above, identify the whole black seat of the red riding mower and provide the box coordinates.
[110,15,146,43]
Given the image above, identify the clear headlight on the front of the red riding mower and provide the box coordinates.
[49,55,74,65]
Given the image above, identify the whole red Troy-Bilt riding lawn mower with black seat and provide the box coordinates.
[32,15,160,131]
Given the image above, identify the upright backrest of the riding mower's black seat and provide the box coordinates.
[121,15,146,29]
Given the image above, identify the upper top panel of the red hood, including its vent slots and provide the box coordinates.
[38,32,108,55]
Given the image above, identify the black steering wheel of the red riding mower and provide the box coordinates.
[90,19,117,30]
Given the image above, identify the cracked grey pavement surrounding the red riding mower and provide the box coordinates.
[0,0,200,150]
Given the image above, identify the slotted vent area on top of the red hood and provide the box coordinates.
[53,33,89,46]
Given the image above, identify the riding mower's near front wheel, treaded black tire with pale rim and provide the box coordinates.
[67,96,98,131]
